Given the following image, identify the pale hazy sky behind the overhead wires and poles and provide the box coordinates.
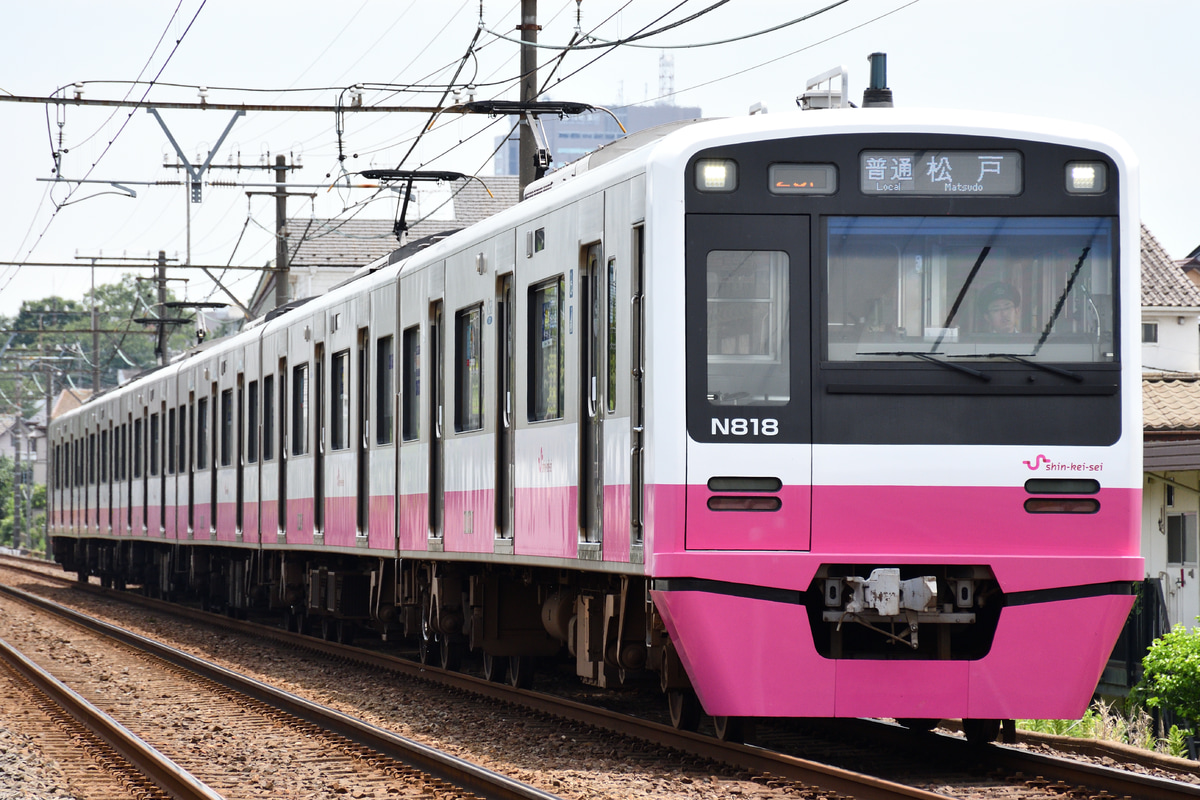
[0,0,1200,315]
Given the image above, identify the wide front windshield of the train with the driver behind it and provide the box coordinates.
[824,216,1116,363]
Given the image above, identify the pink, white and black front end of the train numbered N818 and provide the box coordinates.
[647,110,1142,732]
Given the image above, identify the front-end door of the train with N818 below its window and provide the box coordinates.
[686,215,812,551]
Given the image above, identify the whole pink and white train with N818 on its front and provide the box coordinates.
[50,109,1142,738]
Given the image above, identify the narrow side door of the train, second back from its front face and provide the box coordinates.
[578,243,607,543]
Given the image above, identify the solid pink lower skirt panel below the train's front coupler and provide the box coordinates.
[652,582,1133,718]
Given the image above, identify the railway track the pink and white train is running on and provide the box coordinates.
[4,561,1200,800]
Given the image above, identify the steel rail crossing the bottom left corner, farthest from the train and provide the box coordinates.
[0,639,223,800]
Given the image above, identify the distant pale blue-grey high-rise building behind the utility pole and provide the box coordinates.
[494,104,701,175]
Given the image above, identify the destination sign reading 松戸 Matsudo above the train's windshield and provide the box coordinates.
[858,150,1022,197]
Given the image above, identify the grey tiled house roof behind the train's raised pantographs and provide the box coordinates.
[288,175,520,269]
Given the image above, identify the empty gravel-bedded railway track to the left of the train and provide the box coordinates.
[4,578,556,800]
